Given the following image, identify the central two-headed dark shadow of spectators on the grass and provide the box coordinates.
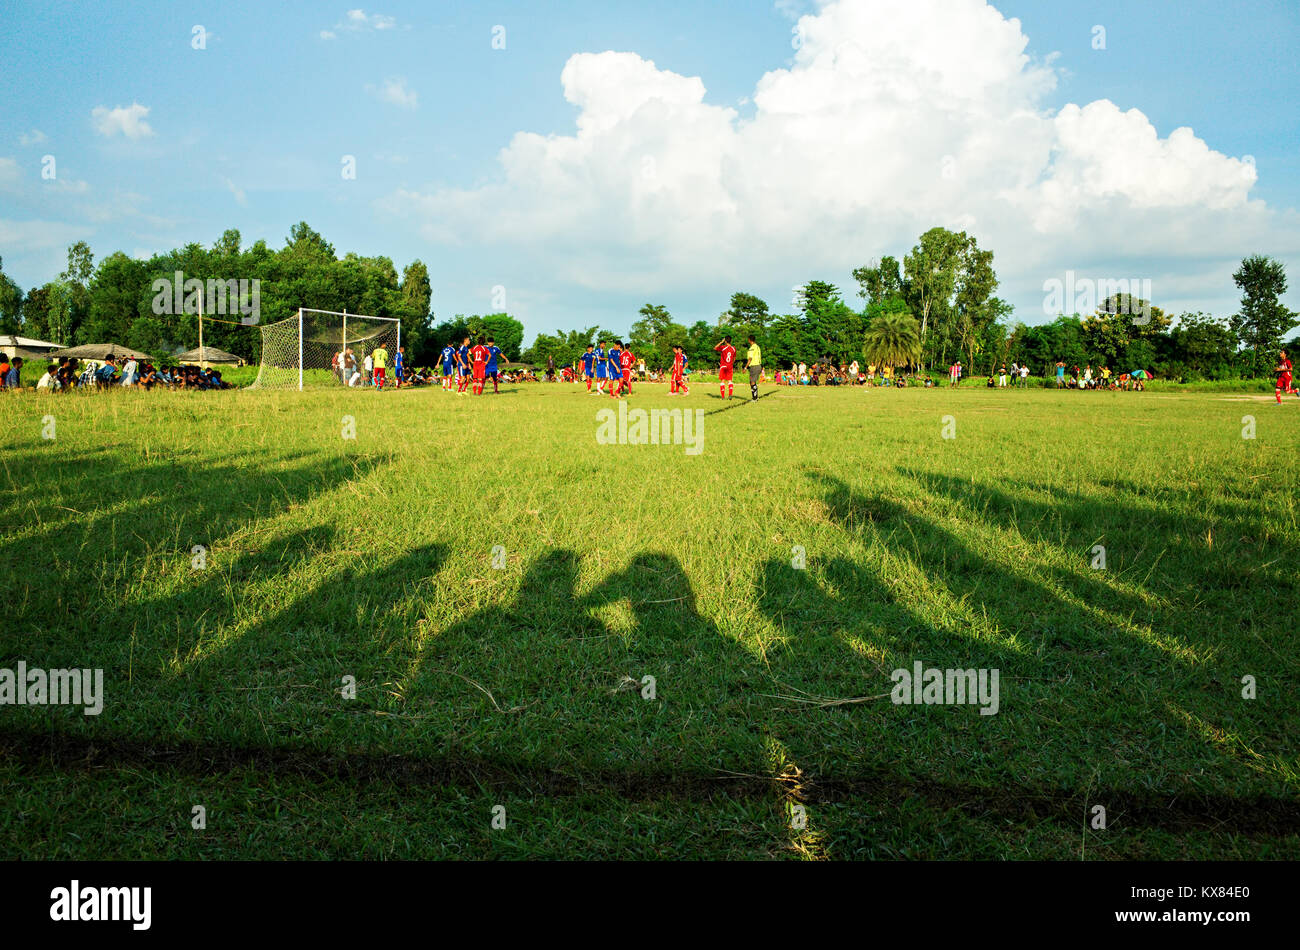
[400,550,763,771]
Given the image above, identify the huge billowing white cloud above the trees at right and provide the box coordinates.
[384,0,1300,318]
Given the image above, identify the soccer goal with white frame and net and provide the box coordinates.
[254,308,402,389]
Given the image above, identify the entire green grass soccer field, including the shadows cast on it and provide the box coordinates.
[0,383,1300,860]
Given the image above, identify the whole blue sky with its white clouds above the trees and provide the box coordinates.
[0,0,1300,338]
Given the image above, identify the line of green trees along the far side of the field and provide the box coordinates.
[0,222,1300,381]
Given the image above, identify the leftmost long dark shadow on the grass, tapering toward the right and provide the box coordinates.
[0,450,378,649]
